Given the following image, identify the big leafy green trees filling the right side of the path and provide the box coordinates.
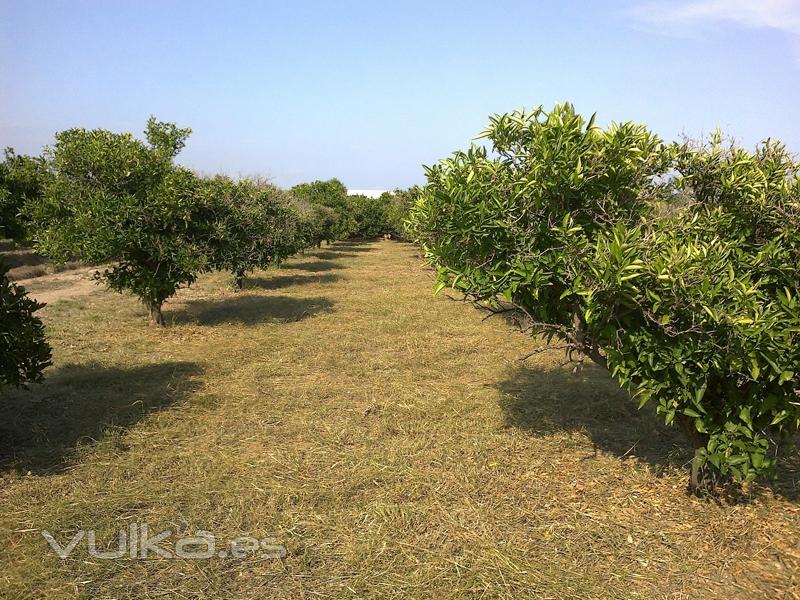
[410,104,800,490]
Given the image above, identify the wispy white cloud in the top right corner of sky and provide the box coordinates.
[631,0,800,36]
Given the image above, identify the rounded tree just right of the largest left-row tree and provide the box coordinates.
[198,176,307,288]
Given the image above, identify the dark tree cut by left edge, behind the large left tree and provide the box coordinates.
[0,148,45,242]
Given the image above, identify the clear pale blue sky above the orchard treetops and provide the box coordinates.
[0,0,800,188]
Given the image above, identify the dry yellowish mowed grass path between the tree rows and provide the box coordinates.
[0,242,800,599]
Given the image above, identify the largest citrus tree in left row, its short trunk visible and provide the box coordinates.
[28,118,209,325]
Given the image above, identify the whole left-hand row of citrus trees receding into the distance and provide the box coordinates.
[0,118,418,394]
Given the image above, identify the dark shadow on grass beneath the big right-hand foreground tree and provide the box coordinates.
[499,365,800,502]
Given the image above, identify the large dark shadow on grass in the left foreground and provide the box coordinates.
[0,362,200,474]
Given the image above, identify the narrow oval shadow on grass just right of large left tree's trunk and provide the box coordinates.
[172,296,333,325]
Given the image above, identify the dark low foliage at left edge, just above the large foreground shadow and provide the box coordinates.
[0,260,50,388]
